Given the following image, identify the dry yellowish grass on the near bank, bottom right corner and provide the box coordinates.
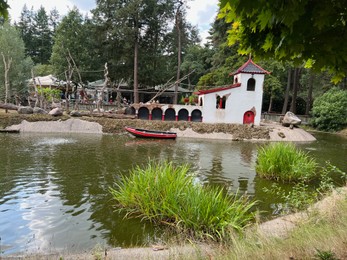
[219,190,347,260]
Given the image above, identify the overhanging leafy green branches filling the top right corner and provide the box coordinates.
[219,0,347,82]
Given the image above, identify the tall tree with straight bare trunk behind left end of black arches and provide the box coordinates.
[92,0,189,103]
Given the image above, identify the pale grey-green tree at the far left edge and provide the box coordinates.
[0,22,32,102]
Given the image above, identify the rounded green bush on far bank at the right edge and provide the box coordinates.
[310,88,347,131]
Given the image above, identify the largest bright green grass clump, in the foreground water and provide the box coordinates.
[110,161,255,240]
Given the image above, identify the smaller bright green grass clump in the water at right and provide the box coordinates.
[255,143,317,182]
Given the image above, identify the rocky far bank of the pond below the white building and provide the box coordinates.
[0,114,316,142]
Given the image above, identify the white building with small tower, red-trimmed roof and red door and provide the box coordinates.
[197,59,270,125]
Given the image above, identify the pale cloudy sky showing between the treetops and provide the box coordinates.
[8,0,218,42]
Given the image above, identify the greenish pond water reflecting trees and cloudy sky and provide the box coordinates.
[0,134,347,256]
